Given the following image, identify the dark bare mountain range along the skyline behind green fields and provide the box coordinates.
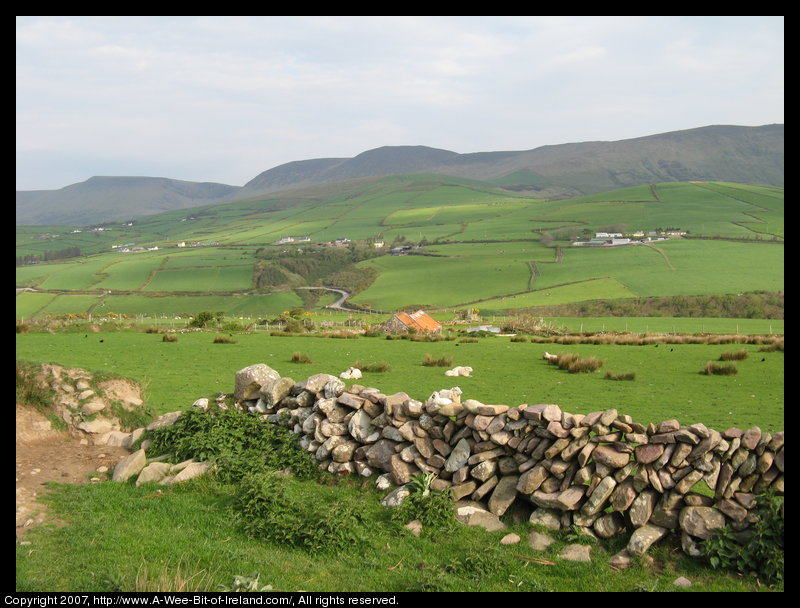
[16,125,784,225]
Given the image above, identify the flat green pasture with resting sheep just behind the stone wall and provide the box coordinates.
[16,331,784,432]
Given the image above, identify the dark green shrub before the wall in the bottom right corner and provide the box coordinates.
[700,490,784,584]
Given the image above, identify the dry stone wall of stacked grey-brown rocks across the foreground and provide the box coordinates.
[234,364,784,555]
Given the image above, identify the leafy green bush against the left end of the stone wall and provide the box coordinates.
[148,409,318,482]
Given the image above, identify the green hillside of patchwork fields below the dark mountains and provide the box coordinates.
[16,175,784,318]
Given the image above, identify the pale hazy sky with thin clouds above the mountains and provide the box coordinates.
[16,16,784,190]
